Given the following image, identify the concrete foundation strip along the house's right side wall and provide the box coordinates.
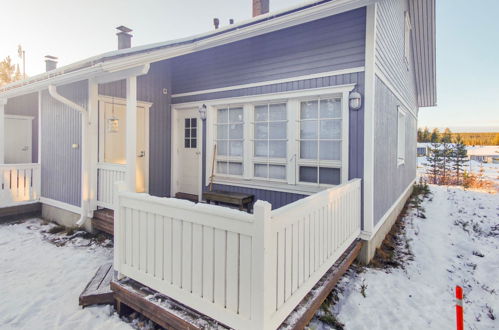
[358,185,413,265]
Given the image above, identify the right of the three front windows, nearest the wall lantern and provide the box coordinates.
[298,99,342,184]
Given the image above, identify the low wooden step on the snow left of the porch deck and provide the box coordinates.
[79,263,114,307]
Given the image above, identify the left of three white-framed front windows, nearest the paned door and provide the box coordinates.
[216,107,244,176]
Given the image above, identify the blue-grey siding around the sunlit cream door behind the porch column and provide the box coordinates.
[99,61,171,197]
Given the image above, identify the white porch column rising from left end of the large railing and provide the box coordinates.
[126,76,137,192]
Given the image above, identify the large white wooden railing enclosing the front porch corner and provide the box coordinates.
[114,179,361,329]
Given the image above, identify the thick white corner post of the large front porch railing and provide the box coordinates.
[251,200,275,330]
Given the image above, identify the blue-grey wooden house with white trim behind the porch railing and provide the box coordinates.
[0,0,436,266]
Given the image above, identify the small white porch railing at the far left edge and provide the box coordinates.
[0,164,40,207]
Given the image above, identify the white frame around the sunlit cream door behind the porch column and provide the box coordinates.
[97,94,153,193]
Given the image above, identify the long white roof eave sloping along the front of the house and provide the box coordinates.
[0,0,376,99]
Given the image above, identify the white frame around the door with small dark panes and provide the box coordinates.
[170,106,205,202]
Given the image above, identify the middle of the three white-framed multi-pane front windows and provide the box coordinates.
[253,103,287,180]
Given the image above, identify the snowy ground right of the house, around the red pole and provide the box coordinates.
[310,186,499,329]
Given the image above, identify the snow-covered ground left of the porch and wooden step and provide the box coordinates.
[0,219,131,330]
